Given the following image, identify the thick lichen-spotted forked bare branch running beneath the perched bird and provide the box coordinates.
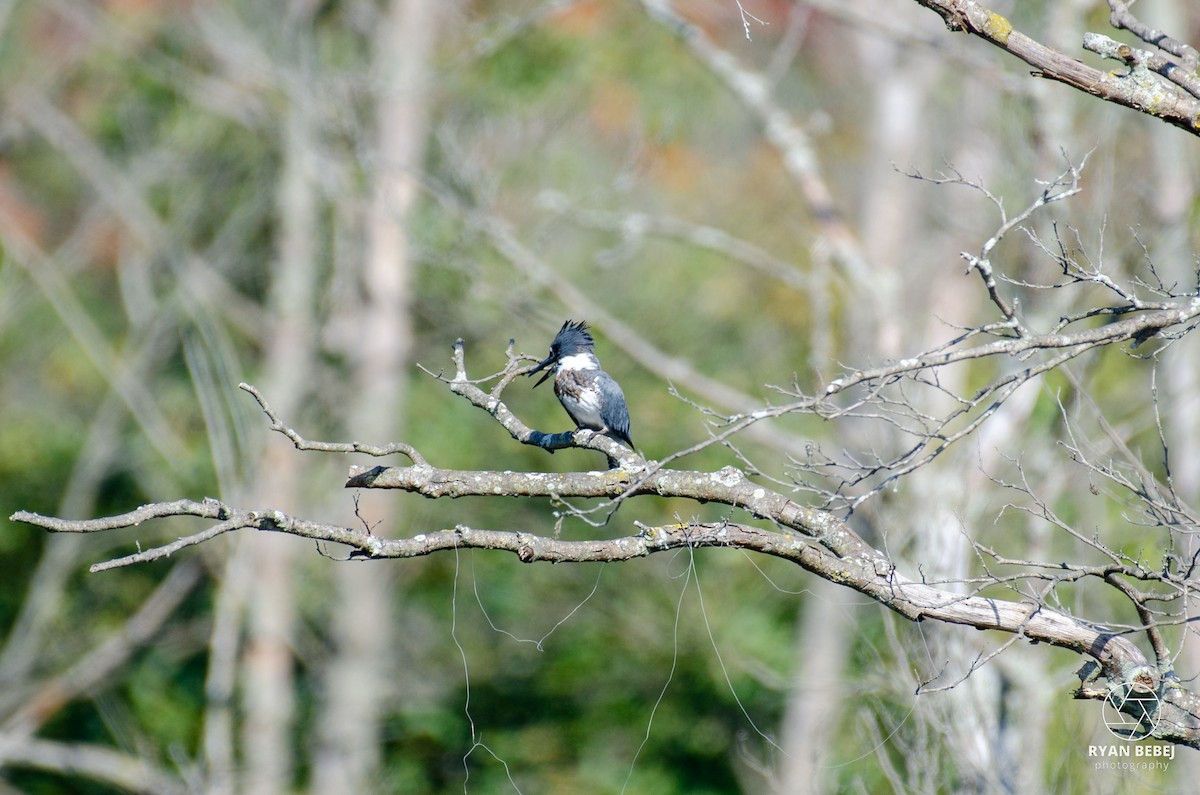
[13,485,1200,747]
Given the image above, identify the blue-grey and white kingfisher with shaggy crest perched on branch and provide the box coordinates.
[528,321,634,448]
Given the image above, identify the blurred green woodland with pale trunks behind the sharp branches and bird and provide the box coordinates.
[0,0,1200,795]
